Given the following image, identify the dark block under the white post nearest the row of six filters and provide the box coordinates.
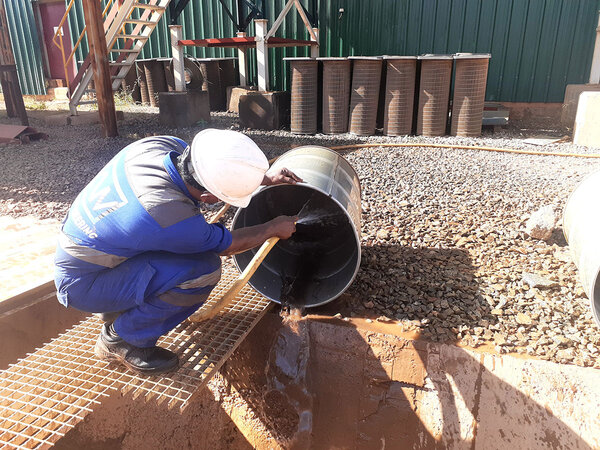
[240,91,290,130]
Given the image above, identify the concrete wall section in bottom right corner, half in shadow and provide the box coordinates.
[475,355,600,449]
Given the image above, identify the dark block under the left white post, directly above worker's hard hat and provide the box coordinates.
[158,90,210,128]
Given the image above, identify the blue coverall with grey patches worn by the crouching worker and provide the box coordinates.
[55,136,231,347]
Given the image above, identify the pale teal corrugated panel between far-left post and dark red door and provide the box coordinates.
[4,0,46,95]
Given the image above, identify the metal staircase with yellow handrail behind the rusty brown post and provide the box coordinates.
[54,0,170,115]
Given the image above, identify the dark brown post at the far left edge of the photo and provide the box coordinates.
[0,0,29,125]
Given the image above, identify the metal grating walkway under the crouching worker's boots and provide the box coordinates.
[0,264,270,448]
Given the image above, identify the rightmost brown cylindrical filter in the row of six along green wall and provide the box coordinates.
[450,53,491,137]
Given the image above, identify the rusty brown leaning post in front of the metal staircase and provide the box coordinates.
[83,0,119,137]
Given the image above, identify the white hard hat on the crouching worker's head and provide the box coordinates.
[189,128,269,208]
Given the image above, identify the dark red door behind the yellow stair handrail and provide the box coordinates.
[39,1,75,80]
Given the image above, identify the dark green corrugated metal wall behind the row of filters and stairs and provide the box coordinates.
[9,0,600,102]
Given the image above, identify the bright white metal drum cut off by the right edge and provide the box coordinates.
[563,171,600,326]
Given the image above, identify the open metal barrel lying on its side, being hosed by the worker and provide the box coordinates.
[232,146,361,307]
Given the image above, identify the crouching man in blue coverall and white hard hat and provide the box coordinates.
[55,129,301,373]
